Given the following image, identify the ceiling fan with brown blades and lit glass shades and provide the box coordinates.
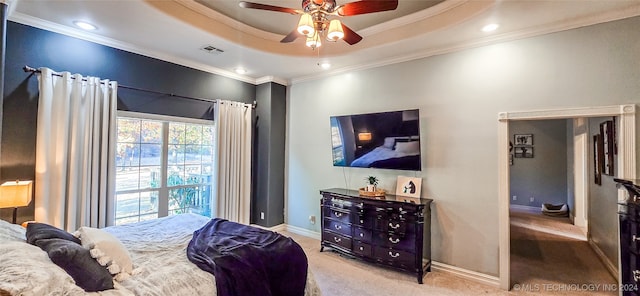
[239,0,398,49]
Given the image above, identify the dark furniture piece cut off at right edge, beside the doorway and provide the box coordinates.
[613,178,640,296]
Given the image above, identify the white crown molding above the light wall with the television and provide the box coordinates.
[291,1,640,85]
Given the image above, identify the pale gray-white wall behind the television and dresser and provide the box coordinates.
[286,18,640,275]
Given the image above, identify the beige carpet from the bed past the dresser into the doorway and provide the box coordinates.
[284,209,616,296]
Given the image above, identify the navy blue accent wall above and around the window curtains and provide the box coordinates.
[0,22,260,222]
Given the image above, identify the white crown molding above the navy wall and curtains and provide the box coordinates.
[9,12,257,85]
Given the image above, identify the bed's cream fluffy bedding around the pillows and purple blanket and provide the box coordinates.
[0,214,321,296]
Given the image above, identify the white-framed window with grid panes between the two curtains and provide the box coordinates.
[114,112,214,225]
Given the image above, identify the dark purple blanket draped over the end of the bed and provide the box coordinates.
[187,218,307,296]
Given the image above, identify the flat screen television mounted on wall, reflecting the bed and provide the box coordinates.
[330,109,422,171]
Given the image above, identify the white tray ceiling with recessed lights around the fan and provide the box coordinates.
[9,0,640,83]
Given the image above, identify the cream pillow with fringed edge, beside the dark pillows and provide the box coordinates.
[76,226,133,281]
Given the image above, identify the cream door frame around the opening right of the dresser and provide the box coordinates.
[498,104,636,290]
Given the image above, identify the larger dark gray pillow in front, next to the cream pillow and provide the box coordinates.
[36,238,113,292]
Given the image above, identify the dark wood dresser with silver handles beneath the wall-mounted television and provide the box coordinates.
[320,188,432,284]
